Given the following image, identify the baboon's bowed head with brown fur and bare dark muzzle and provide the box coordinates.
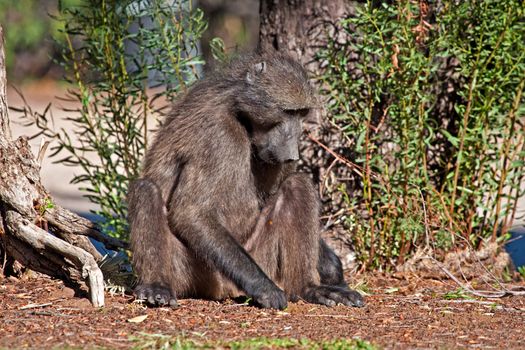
[233,54,318,163]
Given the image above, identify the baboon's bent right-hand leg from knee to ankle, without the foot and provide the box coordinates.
[246,173,320,300]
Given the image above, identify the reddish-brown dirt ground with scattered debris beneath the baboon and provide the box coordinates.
[0,275,525,349]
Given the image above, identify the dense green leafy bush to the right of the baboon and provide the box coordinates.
[318,0,525,267]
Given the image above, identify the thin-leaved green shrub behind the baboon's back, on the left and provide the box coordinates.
[19,0,206,239]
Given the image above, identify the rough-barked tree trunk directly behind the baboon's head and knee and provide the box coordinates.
[259,0,358,268]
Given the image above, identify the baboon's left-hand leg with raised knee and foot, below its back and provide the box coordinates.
[128,179,208,306]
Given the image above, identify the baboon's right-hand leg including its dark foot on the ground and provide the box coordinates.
[246,173,363,306]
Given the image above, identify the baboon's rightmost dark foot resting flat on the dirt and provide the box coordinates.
[303,286,365,307]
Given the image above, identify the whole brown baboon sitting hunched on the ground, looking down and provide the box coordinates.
[128,53,364,309]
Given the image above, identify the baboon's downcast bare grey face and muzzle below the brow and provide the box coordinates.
[252,109,309,164]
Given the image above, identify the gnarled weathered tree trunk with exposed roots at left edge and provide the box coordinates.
[0,27,125,307]
